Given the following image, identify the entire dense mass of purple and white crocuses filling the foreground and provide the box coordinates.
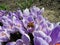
[0,6,60,45]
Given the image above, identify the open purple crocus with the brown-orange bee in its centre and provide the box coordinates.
[22,16,35,32]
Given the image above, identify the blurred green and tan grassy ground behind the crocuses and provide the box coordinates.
[0,0,60,22]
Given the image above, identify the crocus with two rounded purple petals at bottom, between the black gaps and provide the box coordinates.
[16,34,30,45]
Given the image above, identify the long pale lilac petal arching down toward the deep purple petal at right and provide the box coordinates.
[33,31,51,43]
